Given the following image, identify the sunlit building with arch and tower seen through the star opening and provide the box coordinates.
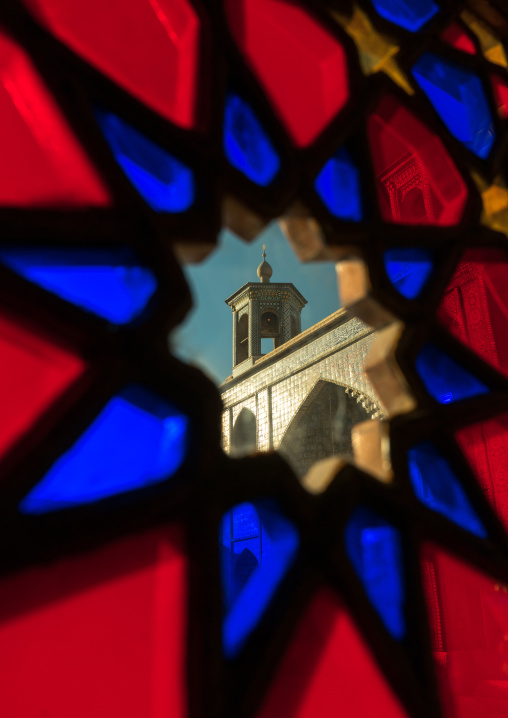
[220,253,384,476]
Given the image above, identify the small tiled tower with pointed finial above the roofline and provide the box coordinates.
[226,245,307,377]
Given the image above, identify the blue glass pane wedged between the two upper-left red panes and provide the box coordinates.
[95,110,196,213]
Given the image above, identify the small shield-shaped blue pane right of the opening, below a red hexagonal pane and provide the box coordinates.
[384,247,434,299]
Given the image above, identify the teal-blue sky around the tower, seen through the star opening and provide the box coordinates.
[171,223,339,384]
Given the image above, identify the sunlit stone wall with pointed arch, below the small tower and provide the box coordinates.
[220,310,383,476]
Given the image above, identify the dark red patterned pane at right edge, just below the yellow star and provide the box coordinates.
[438,250,508,375]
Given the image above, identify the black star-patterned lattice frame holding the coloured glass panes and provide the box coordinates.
[0,0,508,718]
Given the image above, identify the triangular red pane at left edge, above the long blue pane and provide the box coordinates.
[0,33,110,208]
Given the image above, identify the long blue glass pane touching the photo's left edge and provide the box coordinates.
[0,248,157,324]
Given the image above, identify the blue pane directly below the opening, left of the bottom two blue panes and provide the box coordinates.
[219,500,299,658]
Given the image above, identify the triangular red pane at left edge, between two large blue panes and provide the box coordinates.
[0,316,85,456]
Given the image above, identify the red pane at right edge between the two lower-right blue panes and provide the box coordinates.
[455,414,508,530]
